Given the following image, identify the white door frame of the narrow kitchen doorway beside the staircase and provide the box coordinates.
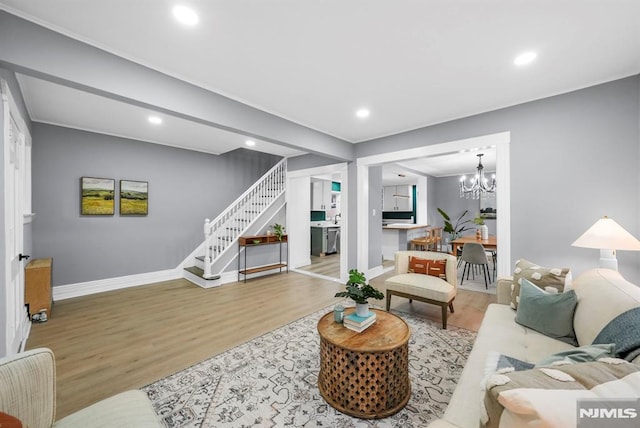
[287,162,349,283]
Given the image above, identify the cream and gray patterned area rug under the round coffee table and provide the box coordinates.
[143,307,476,428]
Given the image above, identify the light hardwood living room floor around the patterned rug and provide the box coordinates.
[27,272,495,419]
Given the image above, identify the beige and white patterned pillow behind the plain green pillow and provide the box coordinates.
[511,259,571,309]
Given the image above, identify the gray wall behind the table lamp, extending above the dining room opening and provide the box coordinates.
[356,76,640,283]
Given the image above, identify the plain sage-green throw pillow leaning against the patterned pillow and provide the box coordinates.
[516,279,578,346]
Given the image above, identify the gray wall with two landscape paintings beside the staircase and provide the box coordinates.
[33,123,280,286]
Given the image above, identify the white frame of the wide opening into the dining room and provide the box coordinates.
[356,132,511,276]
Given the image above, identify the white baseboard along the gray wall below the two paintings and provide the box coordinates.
[52,269,182,301]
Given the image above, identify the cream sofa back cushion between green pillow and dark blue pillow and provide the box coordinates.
[573,269,640,346]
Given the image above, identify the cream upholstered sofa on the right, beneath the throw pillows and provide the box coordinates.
[429,269,640,428]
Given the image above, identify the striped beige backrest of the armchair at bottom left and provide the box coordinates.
[0,348,56,428]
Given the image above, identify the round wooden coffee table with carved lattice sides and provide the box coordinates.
[318,308,411,419]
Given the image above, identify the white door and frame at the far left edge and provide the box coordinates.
[0,79,31,356]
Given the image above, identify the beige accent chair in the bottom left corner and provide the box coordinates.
[0,348,162,428]
